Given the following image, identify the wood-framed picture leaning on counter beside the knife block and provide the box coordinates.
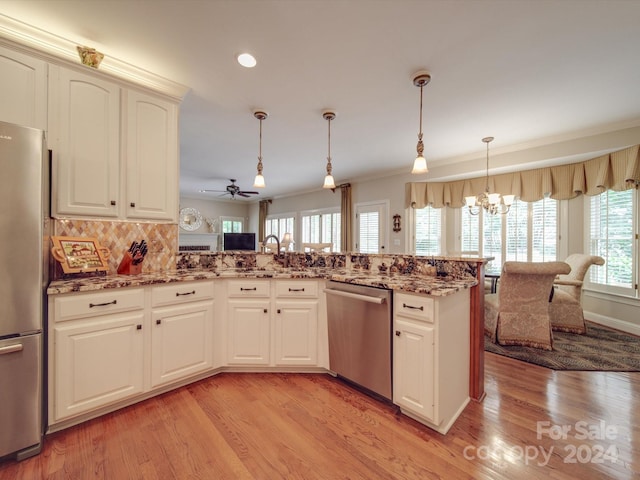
[51,237,110,273]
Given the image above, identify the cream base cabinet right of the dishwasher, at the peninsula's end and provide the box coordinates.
[393,290,470,434]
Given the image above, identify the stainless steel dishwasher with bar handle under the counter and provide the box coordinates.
[325,281,392,400]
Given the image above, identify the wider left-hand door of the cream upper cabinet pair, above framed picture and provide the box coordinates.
[49,65,120,217]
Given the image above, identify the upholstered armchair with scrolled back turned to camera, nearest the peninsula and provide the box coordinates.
[484,262,571,350]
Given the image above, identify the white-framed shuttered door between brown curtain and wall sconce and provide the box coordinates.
[355,202,388,253]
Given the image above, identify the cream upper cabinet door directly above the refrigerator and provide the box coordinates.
[0,47,47,130]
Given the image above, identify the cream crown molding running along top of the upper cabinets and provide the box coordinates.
[0,14,190,101]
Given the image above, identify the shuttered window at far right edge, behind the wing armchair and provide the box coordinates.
[585,189,638,296]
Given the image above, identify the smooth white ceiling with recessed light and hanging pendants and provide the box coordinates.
[0,0,640,200]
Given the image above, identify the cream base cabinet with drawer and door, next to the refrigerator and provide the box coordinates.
[49,289,145,422]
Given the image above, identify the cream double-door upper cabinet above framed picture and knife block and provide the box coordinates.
[49,65,179,222]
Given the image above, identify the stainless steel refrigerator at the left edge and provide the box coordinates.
[0,122,50,460]
